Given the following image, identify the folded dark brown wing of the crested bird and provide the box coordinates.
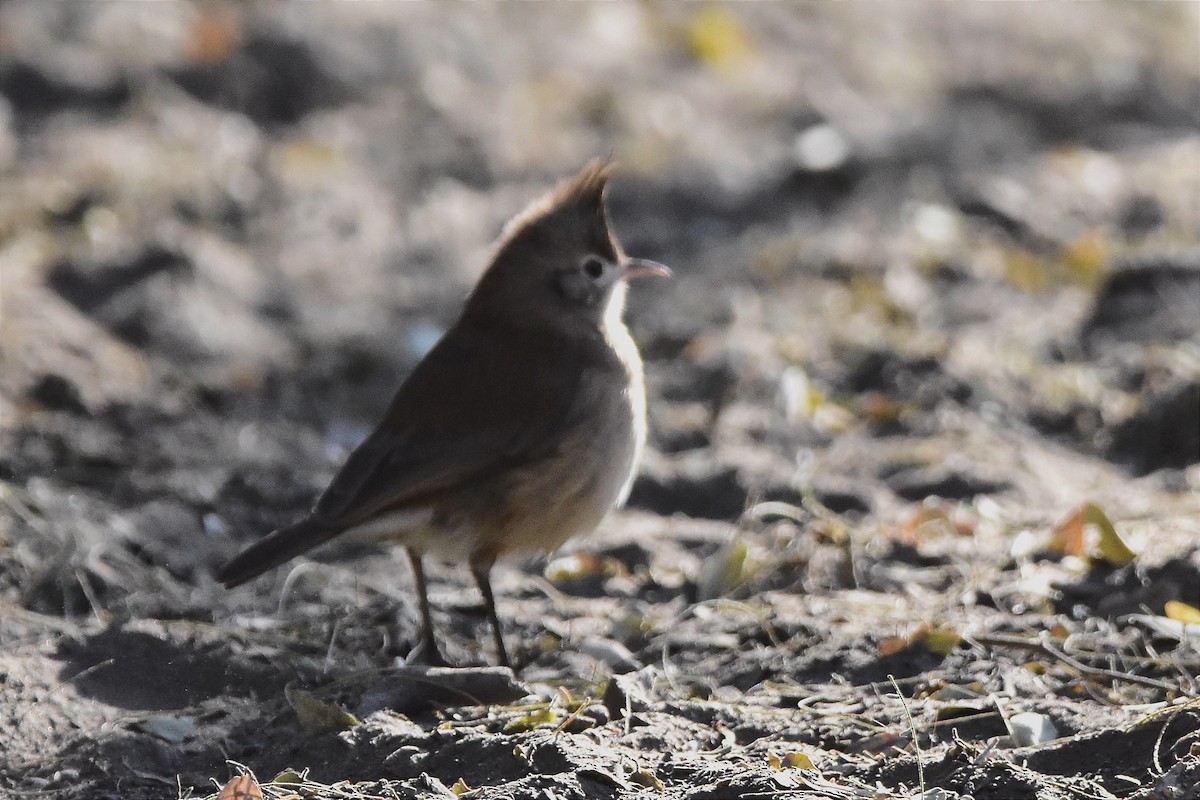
[313,325,605,529]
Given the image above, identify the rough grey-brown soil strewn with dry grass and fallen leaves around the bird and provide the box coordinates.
[0,6,1200,800]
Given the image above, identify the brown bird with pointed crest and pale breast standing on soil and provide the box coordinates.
[216,158,671,666]
